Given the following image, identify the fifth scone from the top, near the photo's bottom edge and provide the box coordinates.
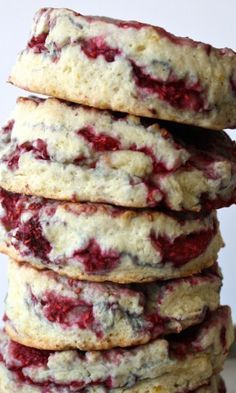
[0,307,233,392]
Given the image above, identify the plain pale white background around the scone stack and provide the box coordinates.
[0,0,236,322]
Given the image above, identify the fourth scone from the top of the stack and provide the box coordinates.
[5,261,221,351]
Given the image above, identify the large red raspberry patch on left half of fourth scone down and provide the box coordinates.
[31,291,102,337]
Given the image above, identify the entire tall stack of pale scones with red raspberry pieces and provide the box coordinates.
[0,9,236,393]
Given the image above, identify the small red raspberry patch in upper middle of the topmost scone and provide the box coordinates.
[81,37,121,63]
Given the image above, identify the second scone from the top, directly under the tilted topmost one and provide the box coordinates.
[0,97,236,211]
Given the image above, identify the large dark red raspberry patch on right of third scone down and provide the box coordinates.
[151,220,217,267]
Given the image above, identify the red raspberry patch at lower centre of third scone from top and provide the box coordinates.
[73,239,120,274]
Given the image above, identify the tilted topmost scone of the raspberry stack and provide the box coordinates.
[10,8,236,129]
